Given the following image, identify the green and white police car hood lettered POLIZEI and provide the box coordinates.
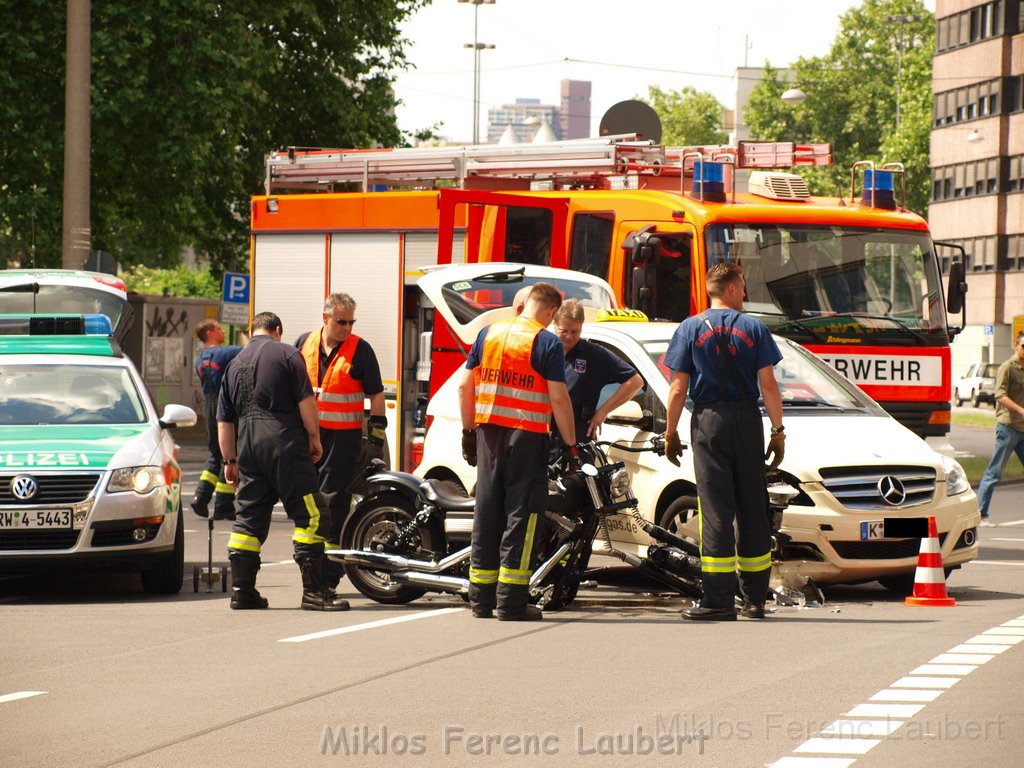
[0,424,160,472]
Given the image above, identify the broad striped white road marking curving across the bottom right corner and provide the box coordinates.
[768,616,1024,768]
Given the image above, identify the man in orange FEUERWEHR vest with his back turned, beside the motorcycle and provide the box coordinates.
[459,283,575,622]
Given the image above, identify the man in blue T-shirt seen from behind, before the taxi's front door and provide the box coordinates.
[665,263,785,622]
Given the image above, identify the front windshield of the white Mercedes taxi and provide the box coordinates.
[643,339,879,413]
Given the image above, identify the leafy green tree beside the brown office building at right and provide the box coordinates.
[745,0,935,215]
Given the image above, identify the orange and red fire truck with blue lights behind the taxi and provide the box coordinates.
[251,135,967,451]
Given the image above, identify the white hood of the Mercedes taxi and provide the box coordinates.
[765,409,945,480]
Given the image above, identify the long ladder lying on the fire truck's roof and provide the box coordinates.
[265,134,831,195]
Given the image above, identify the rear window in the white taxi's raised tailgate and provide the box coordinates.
[441,272,612,324]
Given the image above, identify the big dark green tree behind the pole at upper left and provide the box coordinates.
[0,0,429,272]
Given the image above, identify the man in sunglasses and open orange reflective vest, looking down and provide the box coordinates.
[295,293,387,589]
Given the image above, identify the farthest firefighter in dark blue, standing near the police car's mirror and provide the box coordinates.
[190,319,242,520]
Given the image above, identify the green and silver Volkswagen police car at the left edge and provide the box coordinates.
[0,314,196,594]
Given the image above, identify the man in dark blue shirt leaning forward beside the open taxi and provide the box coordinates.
[555,299,643,442]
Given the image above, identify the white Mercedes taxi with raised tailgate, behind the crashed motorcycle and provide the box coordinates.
[417,310,980,594]
